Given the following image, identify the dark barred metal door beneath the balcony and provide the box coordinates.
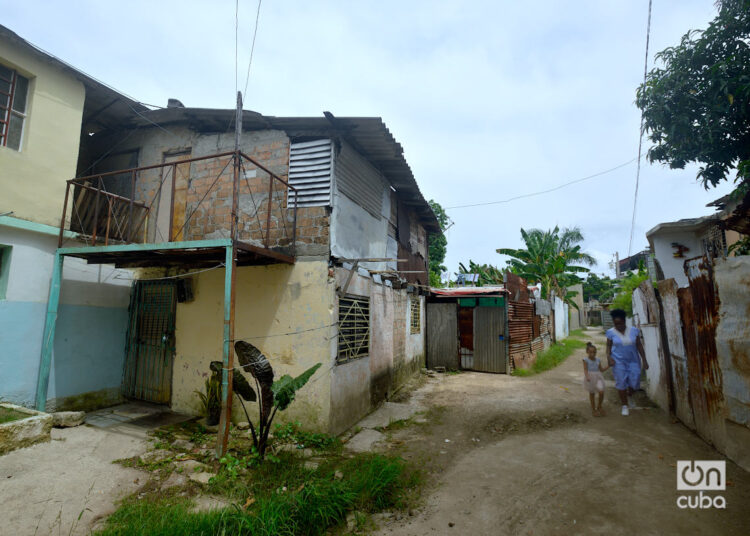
[122,281,177,404]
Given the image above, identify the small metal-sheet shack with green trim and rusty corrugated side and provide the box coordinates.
[426,273,554,374]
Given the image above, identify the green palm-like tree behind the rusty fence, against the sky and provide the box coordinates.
[497,227,596,309]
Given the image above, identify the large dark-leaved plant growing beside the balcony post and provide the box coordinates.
[232,341,320,460]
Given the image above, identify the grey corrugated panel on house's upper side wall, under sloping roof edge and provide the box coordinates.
[334,143,386,219]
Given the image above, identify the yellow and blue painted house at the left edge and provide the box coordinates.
[0,26,144,409]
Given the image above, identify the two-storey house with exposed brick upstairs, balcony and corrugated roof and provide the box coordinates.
[30,86,440,433]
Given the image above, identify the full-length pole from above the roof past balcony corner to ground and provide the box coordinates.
[216,91,242,457]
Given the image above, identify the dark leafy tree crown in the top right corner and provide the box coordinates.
[636,0,750,191]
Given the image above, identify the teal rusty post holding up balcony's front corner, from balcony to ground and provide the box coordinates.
[216,244,237,457]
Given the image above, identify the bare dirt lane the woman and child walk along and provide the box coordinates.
[378,330,750,536]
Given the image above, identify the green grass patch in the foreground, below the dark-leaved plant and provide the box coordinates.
[95,453,422,536]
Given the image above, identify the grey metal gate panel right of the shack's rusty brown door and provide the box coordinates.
[473,307,508,373]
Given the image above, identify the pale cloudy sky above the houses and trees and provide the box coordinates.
[0,0,731,272]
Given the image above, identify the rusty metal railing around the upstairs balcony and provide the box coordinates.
[59,151,297,256]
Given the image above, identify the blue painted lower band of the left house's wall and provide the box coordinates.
[0,301,128,406]
